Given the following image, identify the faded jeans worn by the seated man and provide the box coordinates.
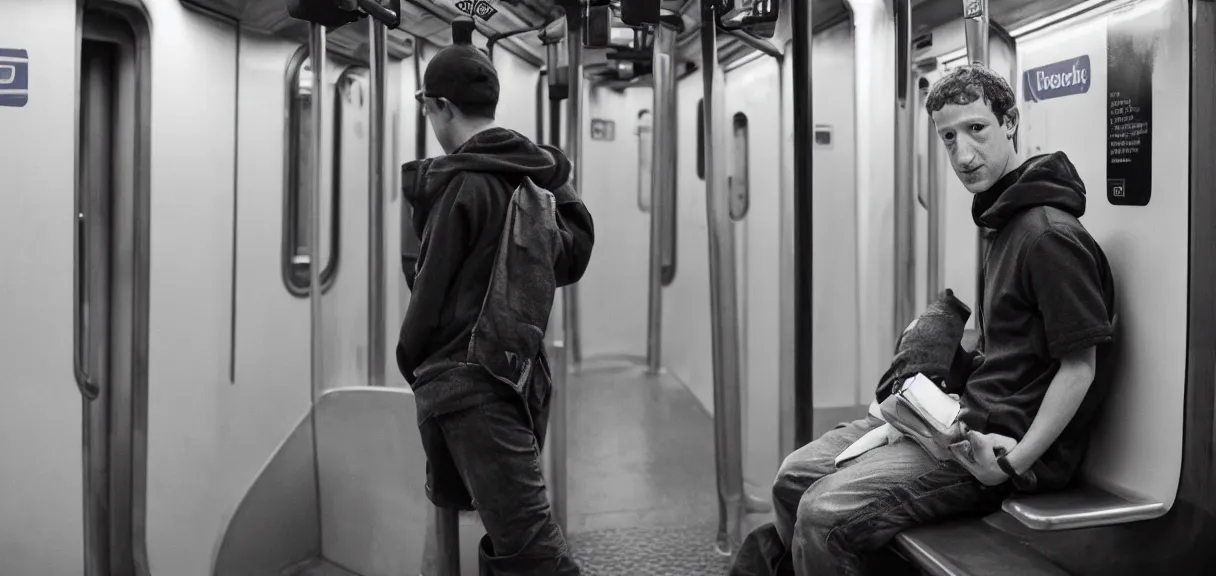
[772,416,1008,576]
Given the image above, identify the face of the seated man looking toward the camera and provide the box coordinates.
[933,98,1017,194]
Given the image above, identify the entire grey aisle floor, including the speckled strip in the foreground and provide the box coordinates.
[567,361,728,576]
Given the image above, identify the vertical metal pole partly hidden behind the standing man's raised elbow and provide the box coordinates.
[562,10,584,372]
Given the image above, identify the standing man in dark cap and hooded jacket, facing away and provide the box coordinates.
[396,32,595,575]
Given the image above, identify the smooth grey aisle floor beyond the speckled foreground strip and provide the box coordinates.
[567,363,717,535]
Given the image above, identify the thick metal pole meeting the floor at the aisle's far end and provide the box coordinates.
[646,23,676,374]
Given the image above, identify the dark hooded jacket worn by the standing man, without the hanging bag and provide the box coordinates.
[396,128,595,417]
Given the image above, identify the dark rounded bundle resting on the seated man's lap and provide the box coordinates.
[874,288,972,402]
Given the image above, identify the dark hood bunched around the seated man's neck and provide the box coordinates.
[972,152,1085,230]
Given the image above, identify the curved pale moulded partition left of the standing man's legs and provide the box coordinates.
[214,386,430,576]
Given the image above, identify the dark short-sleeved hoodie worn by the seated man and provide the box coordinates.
[959,152,1115,490]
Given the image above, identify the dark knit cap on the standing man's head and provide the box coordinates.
[422,44,499,107]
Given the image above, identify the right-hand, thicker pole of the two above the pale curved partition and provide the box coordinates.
[367,18,388,386]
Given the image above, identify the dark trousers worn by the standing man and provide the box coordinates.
[434,400,580,576]
